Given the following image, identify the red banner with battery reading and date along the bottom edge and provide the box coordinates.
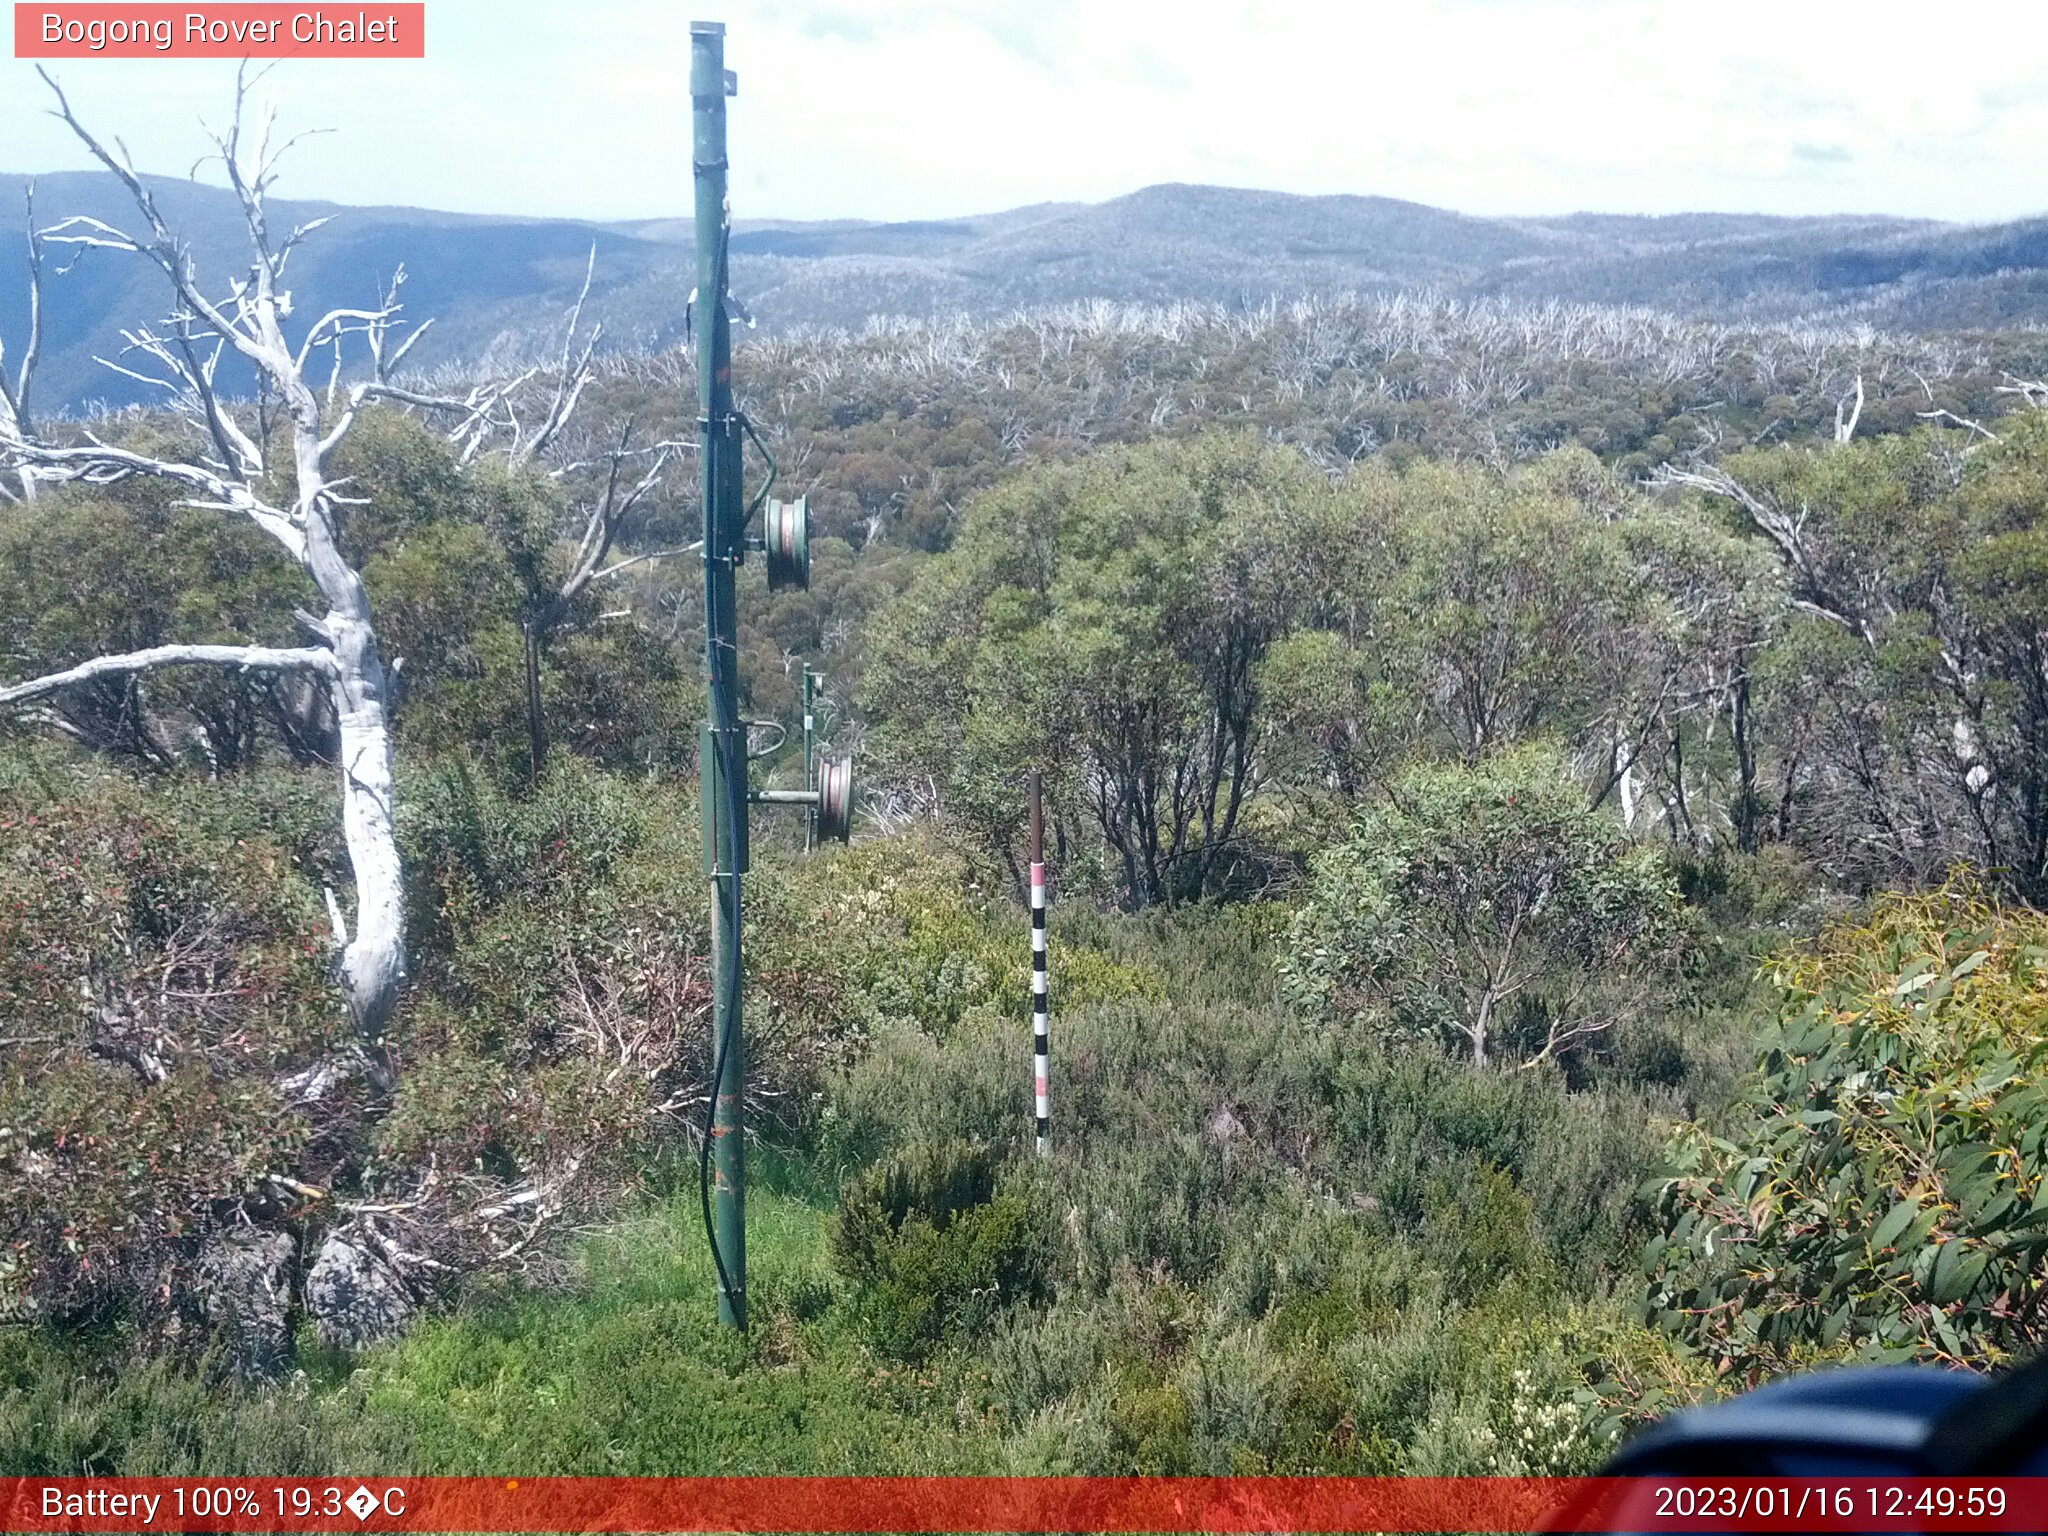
[0,1477,2048,1532]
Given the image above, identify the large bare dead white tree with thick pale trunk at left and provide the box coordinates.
[0,72,506,1075]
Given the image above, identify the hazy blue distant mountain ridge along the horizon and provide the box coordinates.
[0,172,2048,410]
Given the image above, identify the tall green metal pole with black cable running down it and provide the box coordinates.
[690,20,748,1329]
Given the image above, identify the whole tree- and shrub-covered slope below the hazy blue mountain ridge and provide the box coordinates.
[0,141,2048,1475]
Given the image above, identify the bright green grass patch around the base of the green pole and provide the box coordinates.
[350,1192,1007,1477]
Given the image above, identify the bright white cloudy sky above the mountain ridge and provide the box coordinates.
[0,0,2048,219]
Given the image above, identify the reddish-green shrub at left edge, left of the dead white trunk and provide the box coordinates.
[0,760,348,1319]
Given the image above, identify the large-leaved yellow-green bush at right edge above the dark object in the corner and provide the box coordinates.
[1645,885,2048,1380]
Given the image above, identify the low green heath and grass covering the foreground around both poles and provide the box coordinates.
[0,850,1728,1475]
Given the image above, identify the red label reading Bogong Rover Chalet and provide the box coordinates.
[14,0,426,59]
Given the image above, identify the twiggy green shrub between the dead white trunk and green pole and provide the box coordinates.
[385,754,770,1264]
